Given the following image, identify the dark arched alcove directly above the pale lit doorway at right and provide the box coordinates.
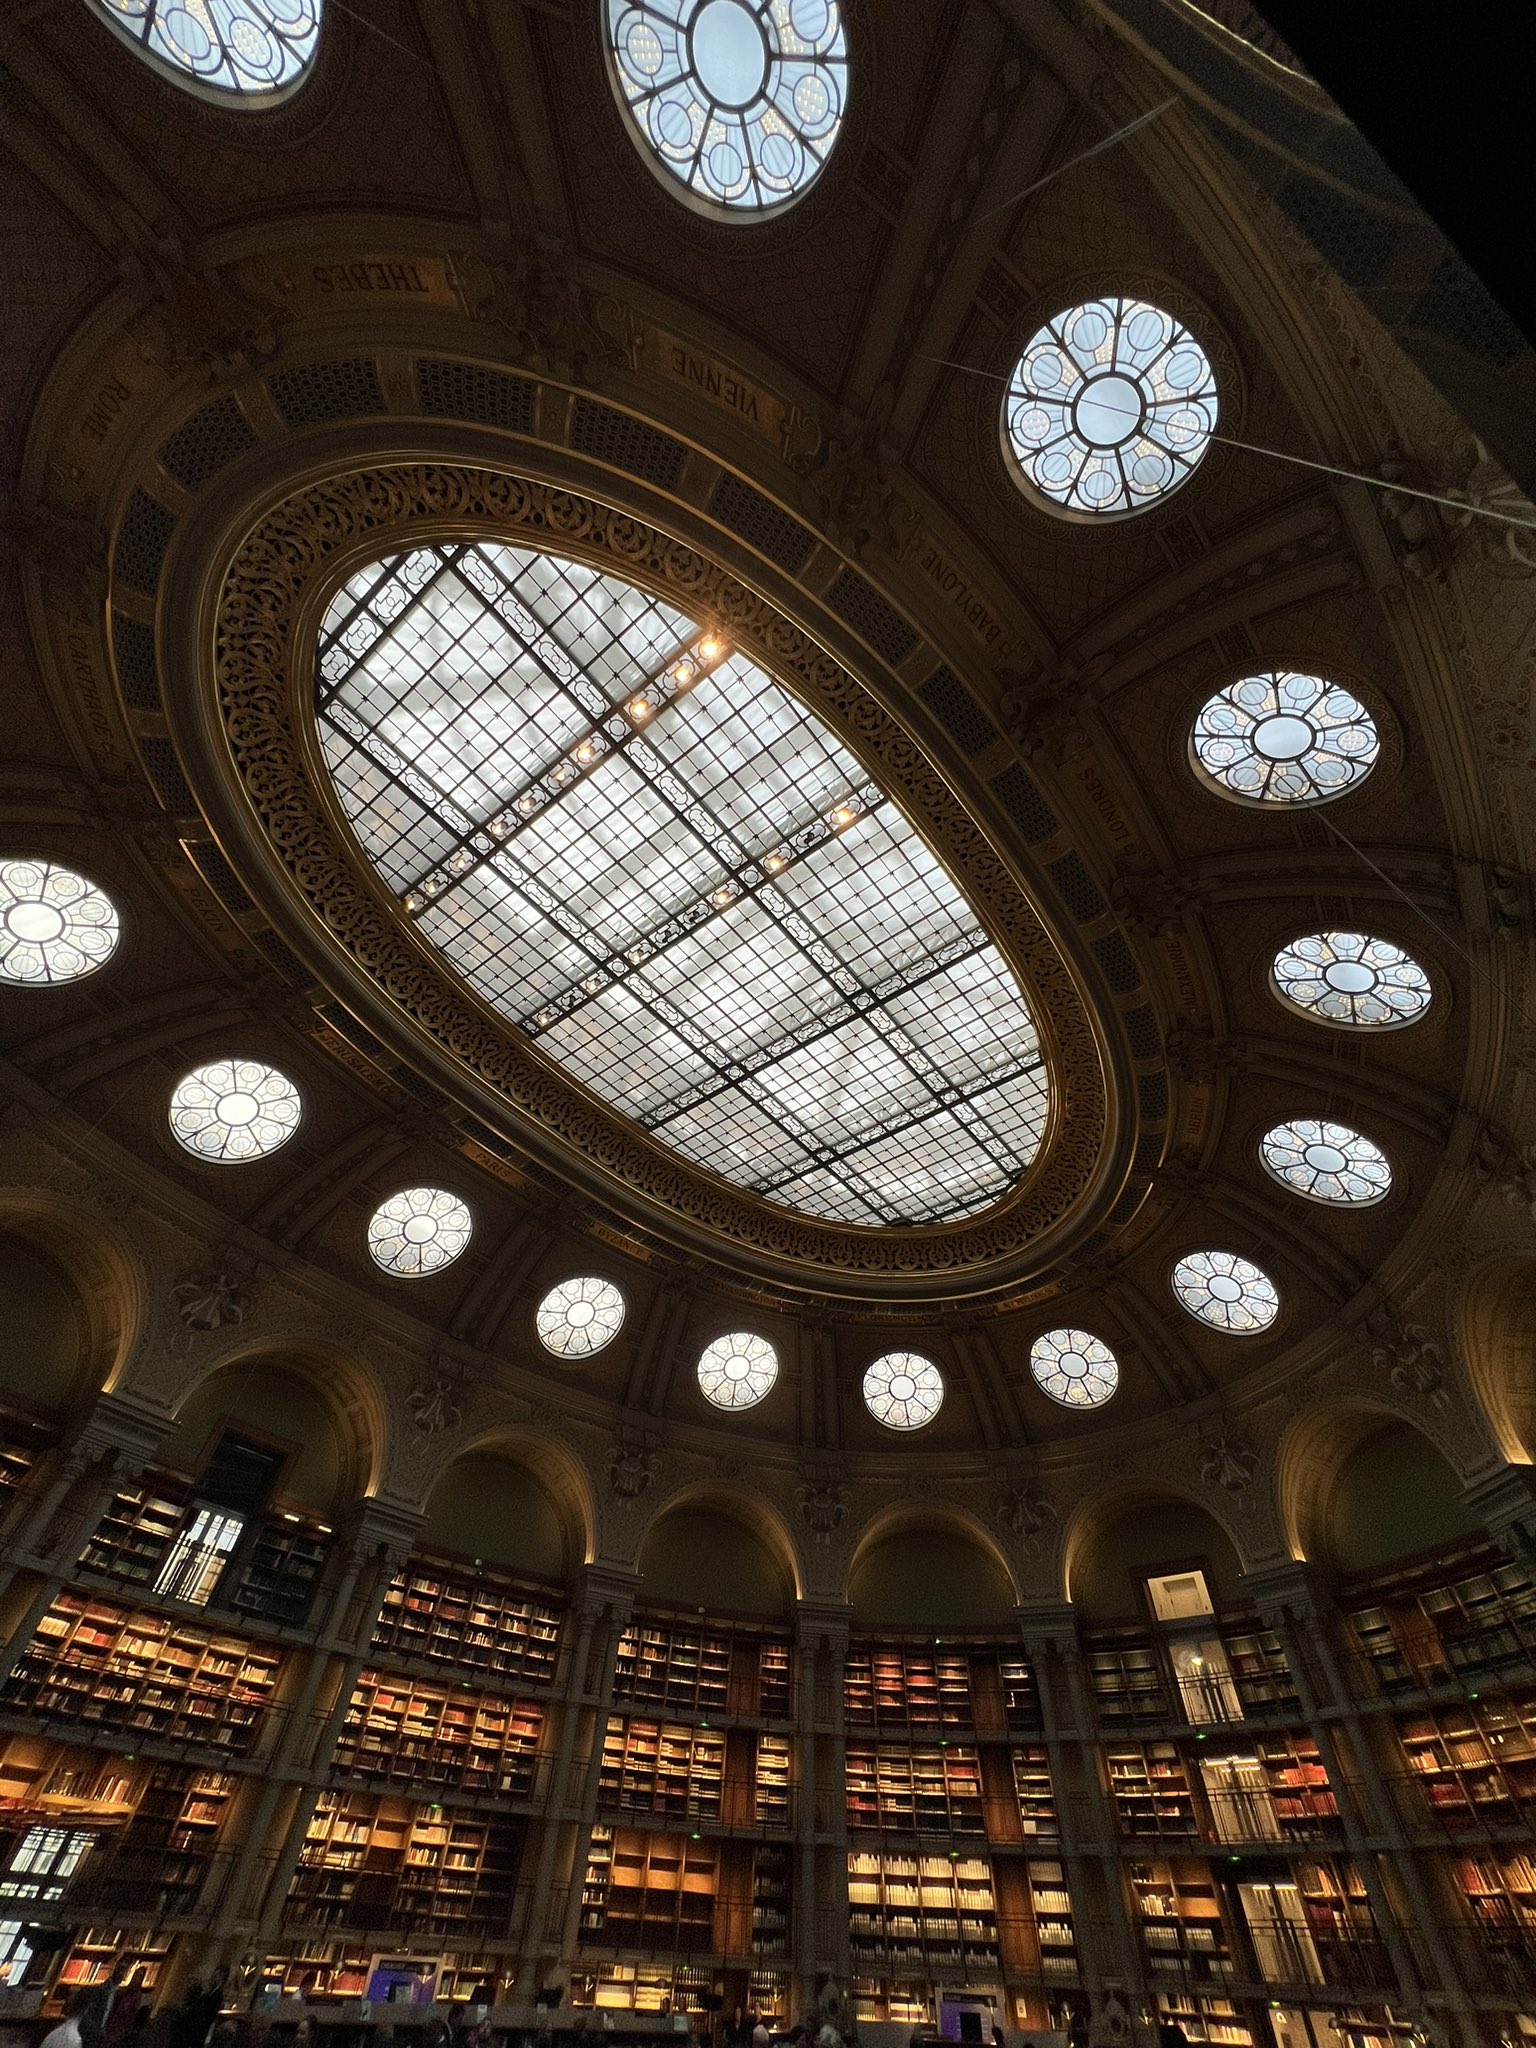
[1067,1487,1243,1622]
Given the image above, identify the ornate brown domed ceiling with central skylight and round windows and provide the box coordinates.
[0,0,1528,1460]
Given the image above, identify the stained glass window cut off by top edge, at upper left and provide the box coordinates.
[90,0,326,98]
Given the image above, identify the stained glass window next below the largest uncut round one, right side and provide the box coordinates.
[1190,668,1380,803]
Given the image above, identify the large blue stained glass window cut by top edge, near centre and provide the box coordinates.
[608,0,848,213]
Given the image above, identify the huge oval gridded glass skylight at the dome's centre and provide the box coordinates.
[317,543,1047,1227]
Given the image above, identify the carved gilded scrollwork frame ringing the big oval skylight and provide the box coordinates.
[188,463,1110,1284]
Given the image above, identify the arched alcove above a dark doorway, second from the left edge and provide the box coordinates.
[160,1352,373,1520]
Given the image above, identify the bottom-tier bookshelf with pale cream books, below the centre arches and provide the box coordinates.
[848,1849,1001,1985]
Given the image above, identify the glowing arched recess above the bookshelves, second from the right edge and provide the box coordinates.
[1278,1395,1473,1569]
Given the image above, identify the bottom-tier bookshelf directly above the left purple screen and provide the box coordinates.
[285,1792,524,1946]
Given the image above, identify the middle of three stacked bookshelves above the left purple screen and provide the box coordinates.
[334,1671,545,1798]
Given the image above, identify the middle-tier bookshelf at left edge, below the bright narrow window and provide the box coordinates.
[0,1593,283,1755]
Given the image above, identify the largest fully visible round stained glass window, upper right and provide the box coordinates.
[1004,299,1217,518]
